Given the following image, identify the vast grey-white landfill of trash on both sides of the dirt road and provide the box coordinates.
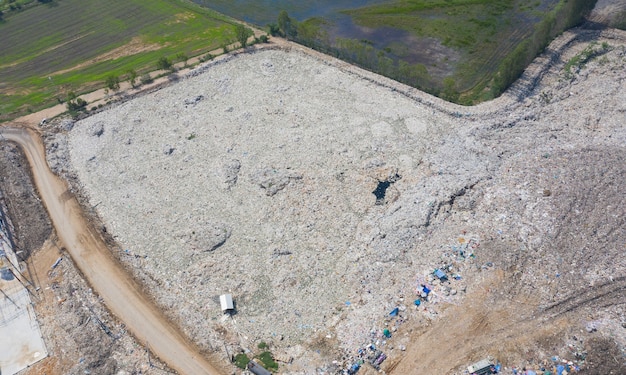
[0,5,626,375]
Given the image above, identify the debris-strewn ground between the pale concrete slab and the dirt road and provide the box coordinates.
[26,242,167,375]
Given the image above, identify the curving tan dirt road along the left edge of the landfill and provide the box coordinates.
[0,127,220,375]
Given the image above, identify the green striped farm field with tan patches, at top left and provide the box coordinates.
[0,0,235,121]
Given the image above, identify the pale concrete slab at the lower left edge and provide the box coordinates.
[0,202,48,375]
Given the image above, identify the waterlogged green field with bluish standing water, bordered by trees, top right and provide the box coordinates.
[196,0,595,104]
